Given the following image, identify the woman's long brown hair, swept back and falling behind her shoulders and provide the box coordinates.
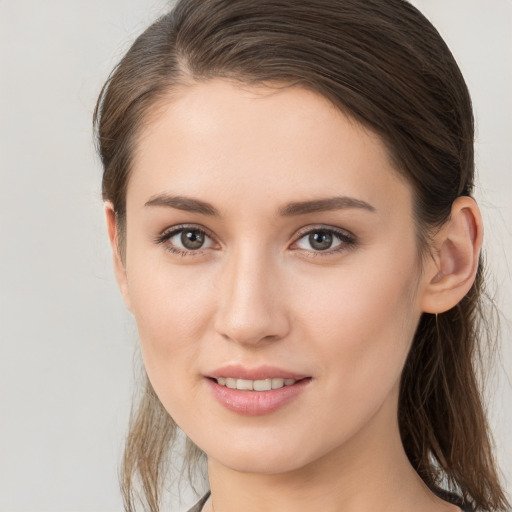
[94,0,508,512]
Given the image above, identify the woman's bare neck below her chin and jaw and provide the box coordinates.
[205,386,456,512]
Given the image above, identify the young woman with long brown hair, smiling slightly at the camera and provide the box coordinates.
[95,0,508,512]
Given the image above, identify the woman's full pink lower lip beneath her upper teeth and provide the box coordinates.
[206,378,311,416]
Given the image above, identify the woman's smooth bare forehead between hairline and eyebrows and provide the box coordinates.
[127,79,411,219]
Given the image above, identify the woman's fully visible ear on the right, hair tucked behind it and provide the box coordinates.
[421,196,483,313]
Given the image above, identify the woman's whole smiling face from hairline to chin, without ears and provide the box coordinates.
[120,80,428,473]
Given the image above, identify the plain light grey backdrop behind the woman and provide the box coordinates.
[0,0,512,512]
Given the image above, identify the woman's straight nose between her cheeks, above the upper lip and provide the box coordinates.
[215,247,290,346]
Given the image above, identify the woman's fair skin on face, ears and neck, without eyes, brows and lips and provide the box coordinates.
[106,79,482,512]
